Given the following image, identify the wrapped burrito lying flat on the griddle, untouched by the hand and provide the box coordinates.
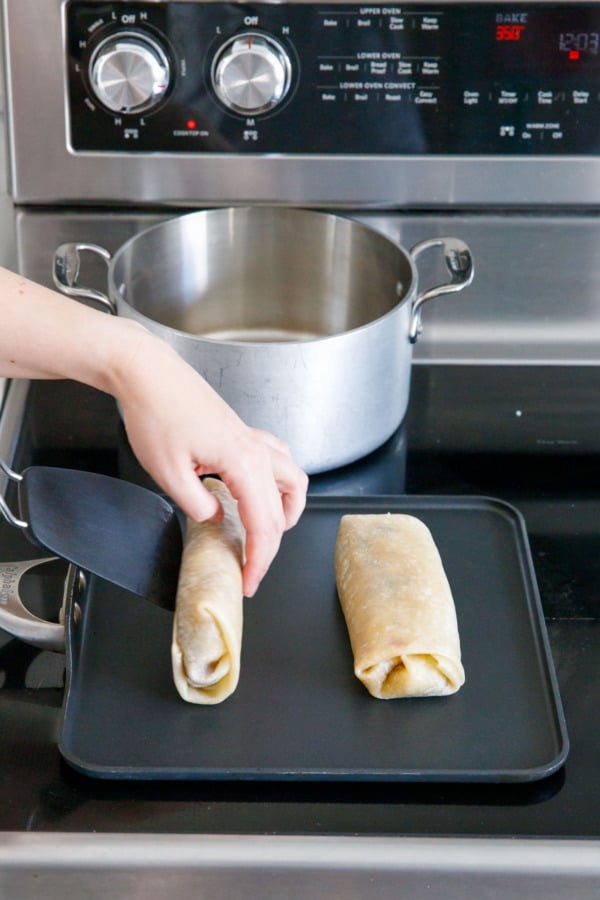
[335,514,465,700]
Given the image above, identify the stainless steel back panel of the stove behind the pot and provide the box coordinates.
[11,209,600,366]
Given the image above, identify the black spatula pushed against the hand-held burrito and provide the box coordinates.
[0,463,183,609]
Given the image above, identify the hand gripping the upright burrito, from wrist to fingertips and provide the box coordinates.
[114,332,308,597]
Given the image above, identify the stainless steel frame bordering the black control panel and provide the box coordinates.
[2,0,600,209]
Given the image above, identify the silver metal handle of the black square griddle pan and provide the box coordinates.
[0,556,83,652]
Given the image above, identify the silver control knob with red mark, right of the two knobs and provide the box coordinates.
[212,32,292,116]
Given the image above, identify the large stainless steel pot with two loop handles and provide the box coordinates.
[54,206,473,473]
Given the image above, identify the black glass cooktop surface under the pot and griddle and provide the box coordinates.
[0,366,600,837]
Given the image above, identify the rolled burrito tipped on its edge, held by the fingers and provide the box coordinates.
[171,478,245,704]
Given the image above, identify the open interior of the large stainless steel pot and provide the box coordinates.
[111,207,414,343]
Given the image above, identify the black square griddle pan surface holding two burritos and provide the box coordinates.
[60,496,568,782]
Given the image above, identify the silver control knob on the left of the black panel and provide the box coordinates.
[89,34,171,113]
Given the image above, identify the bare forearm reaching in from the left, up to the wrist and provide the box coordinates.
[0,268,145,391]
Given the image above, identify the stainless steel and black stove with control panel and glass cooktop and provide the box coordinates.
[0,0,600,900]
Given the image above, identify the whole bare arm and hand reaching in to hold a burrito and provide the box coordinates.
[0,269,307,596]
